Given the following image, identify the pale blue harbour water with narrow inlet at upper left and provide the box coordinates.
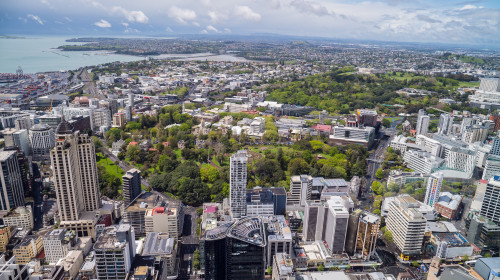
[0,36,245,73]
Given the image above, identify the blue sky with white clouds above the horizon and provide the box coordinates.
[0,0,500,47]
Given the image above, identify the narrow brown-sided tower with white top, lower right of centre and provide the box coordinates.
[354,212,380,259]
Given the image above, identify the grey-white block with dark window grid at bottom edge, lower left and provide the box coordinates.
[94,227,135,280]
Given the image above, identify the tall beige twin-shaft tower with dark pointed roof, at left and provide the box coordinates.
[50,118,101,221]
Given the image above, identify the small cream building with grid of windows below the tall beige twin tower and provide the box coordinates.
[43,229,76,264]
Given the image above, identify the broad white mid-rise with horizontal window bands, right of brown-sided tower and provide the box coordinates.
[386,196,427,257]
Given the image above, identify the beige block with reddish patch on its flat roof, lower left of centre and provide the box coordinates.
[145,205,184,239]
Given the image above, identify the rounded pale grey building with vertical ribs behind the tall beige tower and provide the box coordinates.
[29,124,56,161]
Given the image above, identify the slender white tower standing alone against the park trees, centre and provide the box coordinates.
[229,150,248,218]
